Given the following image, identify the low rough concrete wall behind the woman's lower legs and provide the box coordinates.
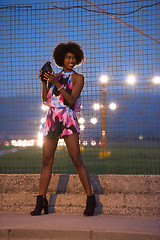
[0,174,160,216]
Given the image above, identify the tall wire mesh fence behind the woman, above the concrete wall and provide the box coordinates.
[0,0,160,174]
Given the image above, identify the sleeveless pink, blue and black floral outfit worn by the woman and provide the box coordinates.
[41,71,81,138]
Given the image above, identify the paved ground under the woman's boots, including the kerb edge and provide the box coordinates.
[0,213,160,240]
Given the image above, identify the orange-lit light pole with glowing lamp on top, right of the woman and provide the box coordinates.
[99,75,111,158]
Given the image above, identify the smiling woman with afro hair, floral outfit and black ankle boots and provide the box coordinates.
[31,42,96,216]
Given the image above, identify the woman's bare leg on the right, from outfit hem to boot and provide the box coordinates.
[64,133,93,196]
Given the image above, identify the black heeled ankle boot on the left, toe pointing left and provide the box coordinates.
[30,195,48,216]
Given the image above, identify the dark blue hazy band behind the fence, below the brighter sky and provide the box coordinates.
[0,95,160,138]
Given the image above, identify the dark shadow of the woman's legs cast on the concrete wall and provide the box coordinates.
[49,174,103,215]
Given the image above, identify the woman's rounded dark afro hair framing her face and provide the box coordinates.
[53,42,84,67]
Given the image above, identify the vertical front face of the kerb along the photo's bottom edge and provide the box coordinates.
[0,229,160,240]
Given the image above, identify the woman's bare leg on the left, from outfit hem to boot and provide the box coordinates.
[39,137,58,195]
